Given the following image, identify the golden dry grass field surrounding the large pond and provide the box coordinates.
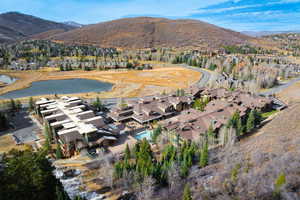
[0,67,201,101]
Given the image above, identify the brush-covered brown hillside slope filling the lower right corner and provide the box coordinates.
[188,104,300,200]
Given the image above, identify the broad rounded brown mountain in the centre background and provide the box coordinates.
[48,17,253,49]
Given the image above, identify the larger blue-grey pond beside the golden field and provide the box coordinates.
[0,79,113,99]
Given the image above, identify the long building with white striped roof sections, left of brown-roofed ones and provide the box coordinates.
[36,96,119,156]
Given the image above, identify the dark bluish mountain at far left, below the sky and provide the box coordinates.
[0,12,74,43]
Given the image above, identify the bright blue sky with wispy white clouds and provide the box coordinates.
[0,0,300,31]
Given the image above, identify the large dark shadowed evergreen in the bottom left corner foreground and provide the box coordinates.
[0,150,69,200]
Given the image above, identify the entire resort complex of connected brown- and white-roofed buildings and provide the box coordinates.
[25,85,284,157]
